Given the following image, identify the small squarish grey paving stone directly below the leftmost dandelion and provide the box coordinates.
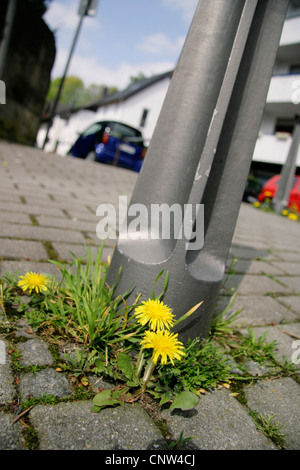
[18,339,53,366]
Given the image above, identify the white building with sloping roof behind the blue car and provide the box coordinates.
[37,71,173,155]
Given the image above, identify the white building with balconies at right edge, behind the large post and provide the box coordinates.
[252,0,300,179]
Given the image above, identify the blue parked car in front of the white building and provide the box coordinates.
[69,121,146,172]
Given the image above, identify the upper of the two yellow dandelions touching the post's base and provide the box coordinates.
[134,299,174,330]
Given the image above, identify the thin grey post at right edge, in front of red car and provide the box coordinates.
[273,116,300,213]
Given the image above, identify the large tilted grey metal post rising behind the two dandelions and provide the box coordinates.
[107,0,288,341]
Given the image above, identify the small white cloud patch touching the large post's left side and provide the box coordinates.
[138,33,185,56]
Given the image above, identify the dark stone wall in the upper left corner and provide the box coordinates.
[0,0,56,145]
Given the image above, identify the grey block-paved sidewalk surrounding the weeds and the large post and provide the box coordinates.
[0,142,300,455]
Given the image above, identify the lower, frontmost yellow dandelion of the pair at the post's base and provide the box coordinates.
[141,330,185,365]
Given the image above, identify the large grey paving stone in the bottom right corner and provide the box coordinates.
[245,378,300,450]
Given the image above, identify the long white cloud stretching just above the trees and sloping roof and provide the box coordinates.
[52,50,175,90]
